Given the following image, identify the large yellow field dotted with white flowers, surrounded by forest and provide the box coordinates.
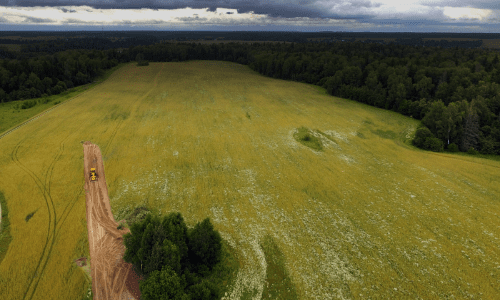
[0,61,500,299]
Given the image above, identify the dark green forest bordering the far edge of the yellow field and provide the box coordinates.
[0,41,500,154]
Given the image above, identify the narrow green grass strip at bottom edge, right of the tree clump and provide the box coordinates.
[261,235,298,300]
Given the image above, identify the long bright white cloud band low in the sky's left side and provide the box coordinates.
[0,6,364,26]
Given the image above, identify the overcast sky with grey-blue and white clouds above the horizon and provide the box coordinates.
[0,0,500,33]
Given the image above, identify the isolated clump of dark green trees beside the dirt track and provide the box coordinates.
[123,213,227,300]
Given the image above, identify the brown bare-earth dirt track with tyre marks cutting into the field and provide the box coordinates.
[83,142,139,300]
